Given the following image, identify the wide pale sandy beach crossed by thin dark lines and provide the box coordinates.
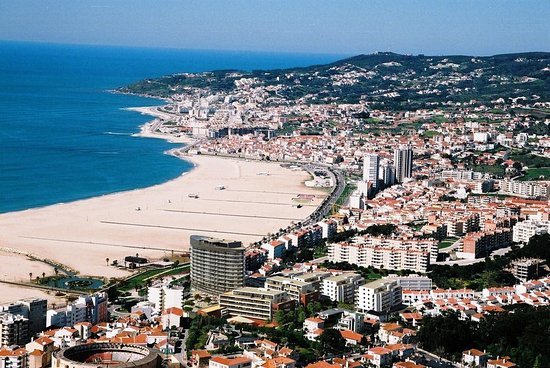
[0,155,326,300]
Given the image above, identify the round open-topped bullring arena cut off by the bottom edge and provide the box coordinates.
[52,343,162,368]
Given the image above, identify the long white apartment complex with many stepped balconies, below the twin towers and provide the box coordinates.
[328,237,439,273]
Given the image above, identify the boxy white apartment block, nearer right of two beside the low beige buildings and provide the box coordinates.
[356,279,402,313]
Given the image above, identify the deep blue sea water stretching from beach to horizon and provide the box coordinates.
[0,42,341,213]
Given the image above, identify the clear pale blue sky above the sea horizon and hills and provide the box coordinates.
[0,0,550,55]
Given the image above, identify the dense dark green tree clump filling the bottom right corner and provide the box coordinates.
[417,304,550,368]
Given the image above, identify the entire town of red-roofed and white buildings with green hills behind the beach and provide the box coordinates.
[0,53,550,368]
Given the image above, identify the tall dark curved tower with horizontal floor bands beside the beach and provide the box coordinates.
[190,235,244,296]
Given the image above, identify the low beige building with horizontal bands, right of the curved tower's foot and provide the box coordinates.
[220,287,296,320]
